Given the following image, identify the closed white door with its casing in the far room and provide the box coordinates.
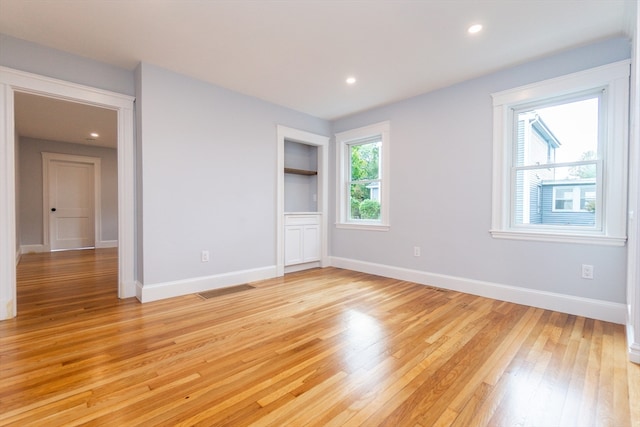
[42,153,102,251]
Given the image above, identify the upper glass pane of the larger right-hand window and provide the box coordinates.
[515,95,600,166]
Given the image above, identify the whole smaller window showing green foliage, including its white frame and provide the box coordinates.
[336,122,389,230]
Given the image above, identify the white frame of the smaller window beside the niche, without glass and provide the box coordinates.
[336,121,390,231]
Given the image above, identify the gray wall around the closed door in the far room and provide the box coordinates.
[16,138,118,245]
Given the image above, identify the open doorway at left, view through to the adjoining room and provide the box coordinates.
[14,92,118,317]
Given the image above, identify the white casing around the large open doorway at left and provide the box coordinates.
[0,67,136,320]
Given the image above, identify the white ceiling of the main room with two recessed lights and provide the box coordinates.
[0,0,636,145]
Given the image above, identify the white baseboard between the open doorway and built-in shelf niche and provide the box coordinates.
[136,265,276,303]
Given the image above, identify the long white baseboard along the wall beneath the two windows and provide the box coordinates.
[331,257,624,324]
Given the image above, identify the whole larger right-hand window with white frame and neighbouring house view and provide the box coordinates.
[491,61,629,245]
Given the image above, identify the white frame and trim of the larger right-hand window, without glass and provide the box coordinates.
[490,60,630,246]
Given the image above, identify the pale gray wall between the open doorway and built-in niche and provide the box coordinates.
[137,64,330,284]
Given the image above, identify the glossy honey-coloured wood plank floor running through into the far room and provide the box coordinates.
[0,249,640,427]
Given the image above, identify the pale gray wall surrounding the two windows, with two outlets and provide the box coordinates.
[330,39,630,303]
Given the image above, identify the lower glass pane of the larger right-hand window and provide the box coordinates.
[513,165,597,226]
